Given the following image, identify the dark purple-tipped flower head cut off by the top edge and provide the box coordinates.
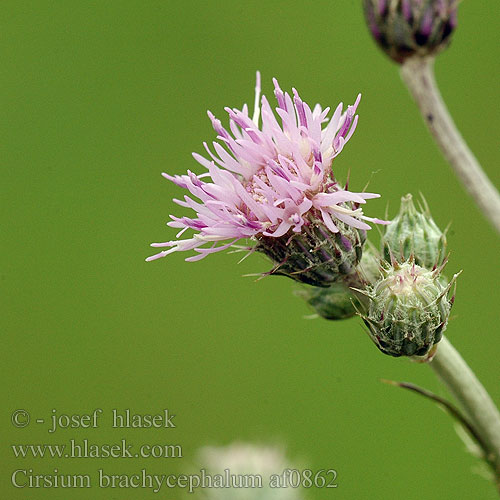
[363,0,458,63]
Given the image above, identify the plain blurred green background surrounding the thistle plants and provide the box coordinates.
[0,0,500,500]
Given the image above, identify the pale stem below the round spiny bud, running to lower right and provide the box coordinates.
[429,337,500,481]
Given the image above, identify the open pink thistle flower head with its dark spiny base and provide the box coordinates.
[146,73,385,286]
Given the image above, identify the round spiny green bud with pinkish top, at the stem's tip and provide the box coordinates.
[361,260,458,357]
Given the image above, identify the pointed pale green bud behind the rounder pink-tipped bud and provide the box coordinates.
[382,194,446,269]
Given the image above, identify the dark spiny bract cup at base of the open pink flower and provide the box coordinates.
[255,220,366,287]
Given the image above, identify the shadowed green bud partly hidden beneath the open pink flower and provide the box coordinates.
[296,283,357,320]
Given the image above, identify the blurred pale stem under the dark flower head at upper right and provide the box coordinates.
[401,56,500,233]
